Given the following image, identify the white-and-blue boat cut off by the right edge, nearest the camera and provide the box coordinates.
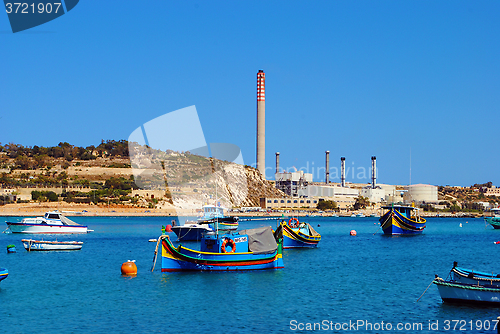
[433,275,500,307]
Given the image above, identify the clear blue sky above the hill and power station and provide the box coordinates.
[0,0,500,186]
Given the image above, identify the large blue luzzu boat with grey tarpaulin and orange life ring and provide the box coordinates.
[153,227,284,272]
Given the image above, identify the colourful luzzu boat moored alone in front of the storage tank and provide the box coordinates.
[379,205,426,235]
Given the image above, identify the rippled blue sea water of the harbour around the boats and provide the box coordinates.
[0,217,500,334]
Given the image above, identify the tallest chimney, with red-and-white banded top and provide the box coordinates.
[257,70,266,178]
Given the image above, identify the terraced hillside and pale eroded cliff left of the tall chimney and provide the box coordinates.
[0,152,286,210]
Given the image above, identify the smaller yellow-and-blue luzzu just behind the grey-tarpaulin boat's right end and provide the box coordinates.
[274,218,321,249]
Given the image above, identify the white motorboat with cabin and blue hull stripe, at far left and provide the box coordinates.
[6,211,92,234]
